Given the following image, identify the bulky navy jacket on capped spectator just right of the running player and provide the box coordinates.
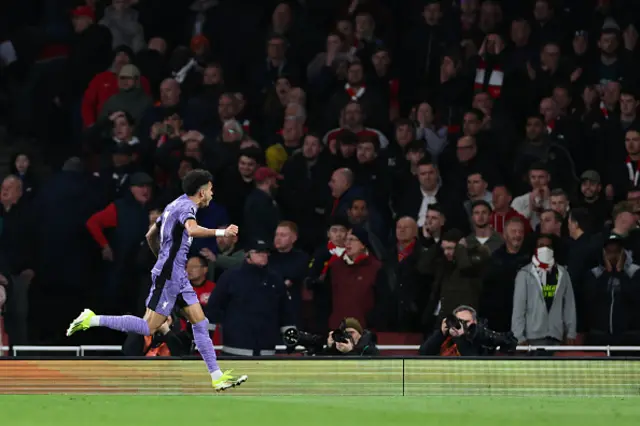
[206,262,294,355]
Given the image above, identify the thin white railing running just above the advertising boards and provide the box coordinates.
[0,345,640,357]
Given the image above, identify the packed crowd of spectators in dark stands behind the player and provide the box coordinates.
[0,0,640,353]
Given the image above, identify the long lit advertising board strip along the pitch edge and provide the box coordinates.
[0,358,640,397]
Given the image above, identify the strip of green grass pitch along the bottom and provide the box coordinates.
[0,395,640,426]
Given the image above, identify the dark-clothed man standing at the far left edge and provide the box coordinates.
[0,175,35,345]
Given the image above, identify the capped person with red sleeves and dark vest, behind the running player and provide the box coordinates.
[87,172,153,312]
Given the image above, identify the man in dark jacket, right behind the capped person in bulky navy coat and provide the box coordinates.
[269,220,309,326]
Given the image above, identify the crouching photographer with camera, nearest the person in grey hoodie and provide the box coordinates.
[418,305,518,356]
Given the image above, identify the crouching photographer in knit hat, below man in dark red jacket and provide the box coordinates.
[323,318,380,356]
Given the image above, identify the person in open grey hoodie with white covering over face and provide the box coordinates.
[511,234,576,346]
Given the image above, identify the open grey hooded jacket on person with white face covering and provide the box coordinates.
[511,263,576,342]
